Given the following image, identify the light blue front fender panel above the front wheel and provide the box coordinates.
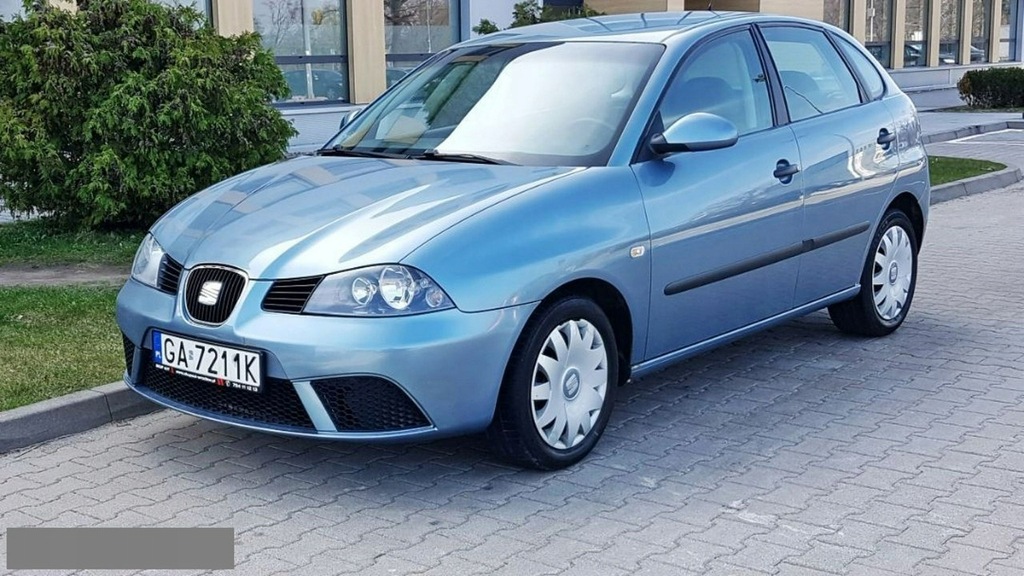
[402,167,650,358]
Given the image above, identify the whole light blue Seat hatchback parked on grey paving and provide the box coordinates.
[117,11,929,468]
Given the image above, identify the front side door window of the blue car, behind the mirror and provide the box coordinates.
[658,30,772,135]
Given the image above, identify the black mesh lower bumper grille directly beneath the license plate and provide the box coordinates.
[139,360,314,431]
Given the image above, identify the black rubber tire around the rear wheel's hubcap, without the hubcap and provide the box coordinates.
[828,209,918,337]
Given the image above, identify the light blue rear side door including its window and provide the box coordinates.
[761,25,899,306]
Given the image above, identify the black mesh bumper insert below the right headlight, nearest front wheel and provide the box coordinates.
[312,376,430,431]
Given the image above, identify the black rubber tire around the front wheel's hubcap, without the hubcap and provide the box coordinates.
[487,296,618,470]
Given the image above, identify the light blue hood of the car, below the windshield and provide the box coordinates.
[153,156,581,279]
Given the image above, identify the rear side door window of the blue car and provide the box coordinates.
[763,27,860,121]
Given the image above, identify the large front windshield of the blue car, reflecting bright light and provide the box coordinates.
[325,42,663,166]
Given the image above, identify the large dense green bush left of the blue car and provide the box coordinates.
[0,0,294,228]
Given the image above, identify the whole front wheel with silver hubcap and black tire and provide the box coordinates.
[487,297,618,469]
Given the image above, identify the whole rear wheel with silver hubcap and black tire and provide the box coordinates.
[828,209,918,336]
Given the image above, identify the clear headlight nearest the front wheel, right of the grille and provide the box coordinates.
[302,264,455,316]
